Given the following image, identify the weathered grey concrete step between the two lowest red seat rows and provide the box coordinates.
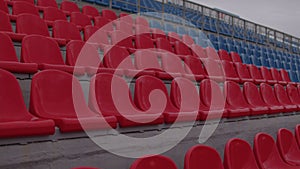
[0,115,300,169]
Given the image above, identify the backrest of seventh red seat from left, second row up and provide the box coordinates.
[224,81,249,107]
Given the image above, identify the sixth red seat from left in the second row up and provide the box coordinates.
[199,79,228,120]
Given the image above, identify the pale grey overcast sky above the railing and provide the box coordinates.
[192,0,300,38]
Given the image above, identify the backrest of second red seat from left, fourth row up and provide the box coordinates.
[17,14,50,37]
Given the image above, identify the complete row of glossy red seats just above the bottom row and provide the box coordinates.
[0,66,300,137]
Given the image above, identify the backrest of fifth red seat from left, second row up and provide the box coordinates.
[170,77,200,111]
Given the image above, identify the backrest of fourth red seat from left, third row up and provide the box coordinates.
[103,46,136,70]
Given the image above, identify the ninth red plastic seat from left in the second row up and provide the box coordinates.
[260,83,285,112]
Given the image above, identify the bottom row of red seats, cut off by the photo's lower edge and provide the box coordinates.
[70,125,300,169]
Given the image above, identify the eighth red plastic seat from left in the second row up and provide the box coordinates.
[243,82,272,114]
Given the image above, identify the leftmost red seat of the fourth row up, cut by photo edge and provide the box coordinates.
[0,11,25,42]
